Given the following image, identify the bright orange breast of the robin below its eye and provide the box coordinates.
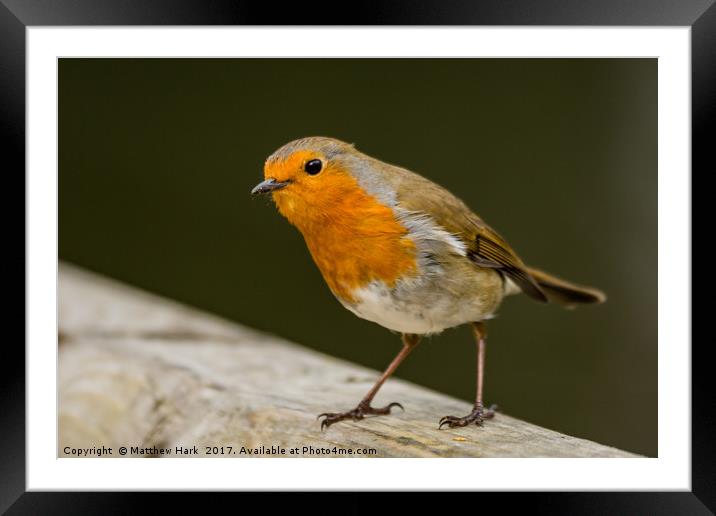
[274,171,417,302]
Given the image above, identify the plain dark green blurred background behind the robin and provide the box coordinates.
[59,59,657,455]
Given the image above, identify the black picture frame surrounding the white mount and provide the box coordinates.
[0,0,716,514]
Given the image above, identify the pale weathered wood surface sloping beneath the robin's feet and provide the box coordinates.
[58,265,635,457]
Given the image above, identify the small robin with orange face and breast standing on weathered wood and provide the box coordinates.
[251,137,606,429]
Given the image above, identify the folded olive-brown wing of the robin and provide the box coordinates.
[386,163,547,302]
